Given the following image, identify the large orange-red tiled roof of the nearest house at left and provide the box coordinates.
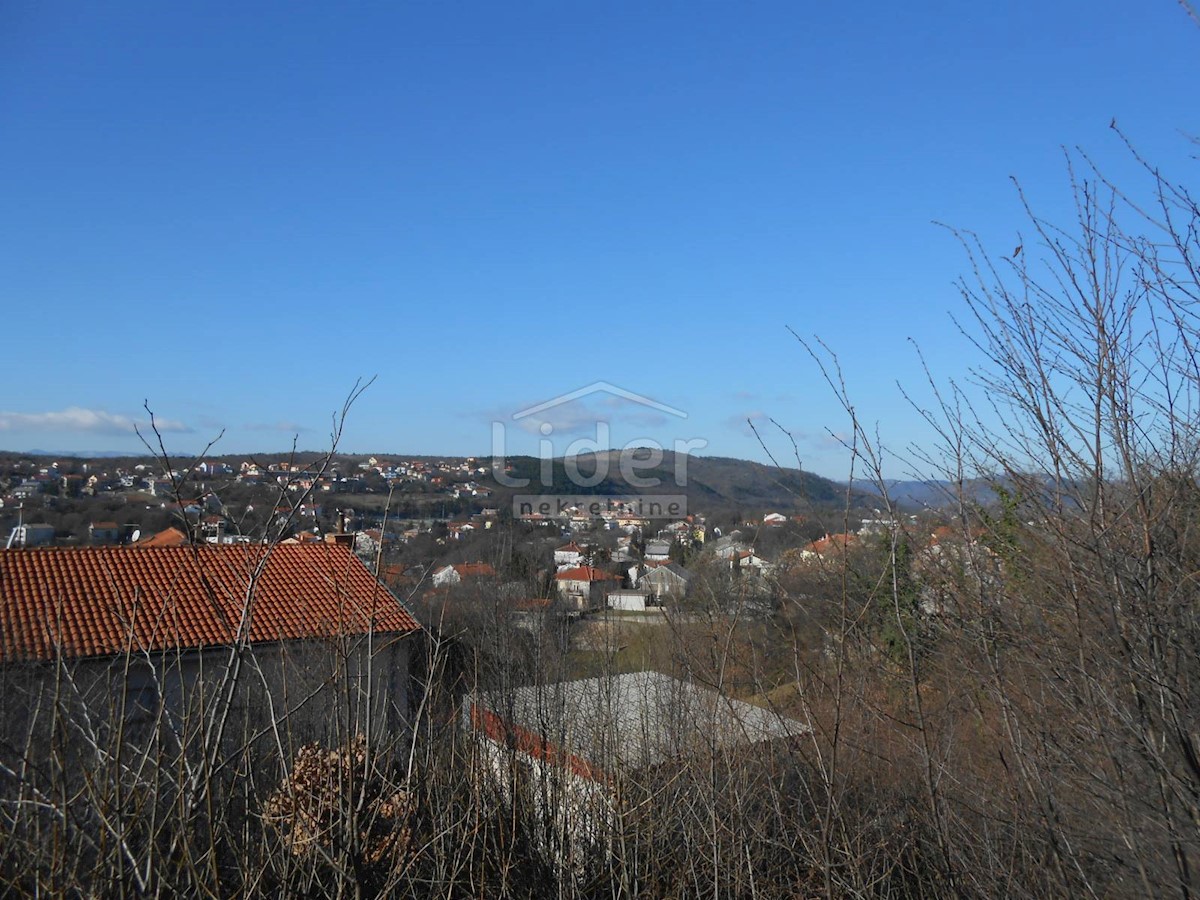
[0,544,420,661]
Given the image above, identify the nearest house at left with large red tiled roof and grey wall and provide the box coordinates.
[0,542,420,745]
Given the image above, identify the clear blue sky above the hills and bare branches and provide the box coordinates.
[0,0,1200,478]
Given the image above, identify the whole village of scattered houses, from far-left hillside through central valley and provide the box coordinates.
[0,456,952,633]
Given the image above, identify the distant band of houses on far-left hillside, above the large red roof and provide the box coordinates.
[0,455,494,554]
